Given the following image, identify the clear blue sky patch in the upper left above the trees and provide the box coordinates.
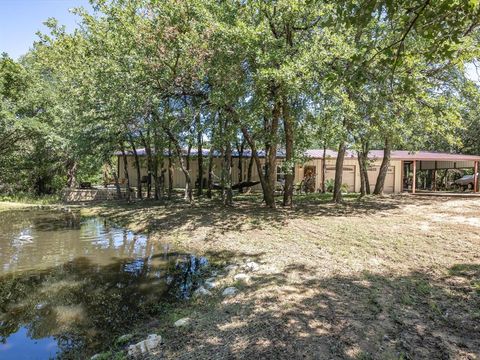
[0,0,91,59]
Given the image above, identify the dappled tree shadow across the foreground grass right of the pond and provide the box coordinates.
[164,264,480,359]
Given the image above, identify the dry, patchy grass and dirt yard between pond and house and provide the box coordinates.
[88,196,480,359]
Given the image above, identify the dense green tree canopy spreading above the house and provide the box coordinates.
[0,0,479,200]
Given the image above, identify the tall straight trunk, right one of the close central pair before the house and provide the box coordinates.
[282,97,295,207]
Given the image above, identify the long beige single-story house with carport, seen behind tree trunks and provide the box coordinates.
[116,149,480,193]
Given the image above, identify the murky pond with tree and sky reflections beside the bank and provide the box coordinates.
[0,210,208,359]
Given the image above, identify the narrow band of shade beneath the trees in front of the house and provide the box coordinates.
[94,193,412,233]
